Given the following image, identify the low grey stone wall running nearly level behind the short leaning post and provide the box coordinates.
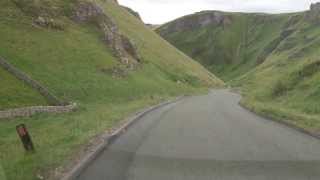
[0,104,77,119]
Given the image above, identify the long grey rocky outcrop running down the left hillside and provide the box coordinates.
[72,2,140,67]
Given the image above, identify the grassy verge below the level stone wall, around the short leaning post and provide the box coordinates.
[0,97,175,179]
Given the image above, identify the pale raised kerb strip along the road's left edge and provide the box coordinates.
[58,96,186,180]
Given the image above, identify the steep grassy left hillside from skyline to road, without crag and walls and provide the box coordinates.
[0,0,222,180]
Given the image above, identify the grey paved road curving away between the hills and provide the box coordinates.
[78,90,320,180]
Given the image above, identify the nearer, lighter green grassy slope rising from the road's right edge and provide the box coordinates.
[233,17,320,133]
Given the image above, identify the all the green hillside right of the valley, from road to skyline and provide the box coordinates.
[157,4,320,133]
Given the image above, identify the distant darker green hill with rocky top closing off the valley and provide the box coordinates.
[156,11,291,80]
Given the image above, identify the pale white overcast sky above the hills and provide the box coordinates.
[118,0,320,24]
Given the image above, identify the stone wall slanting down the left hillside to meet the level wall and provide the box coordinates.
[0,57,67,106]
